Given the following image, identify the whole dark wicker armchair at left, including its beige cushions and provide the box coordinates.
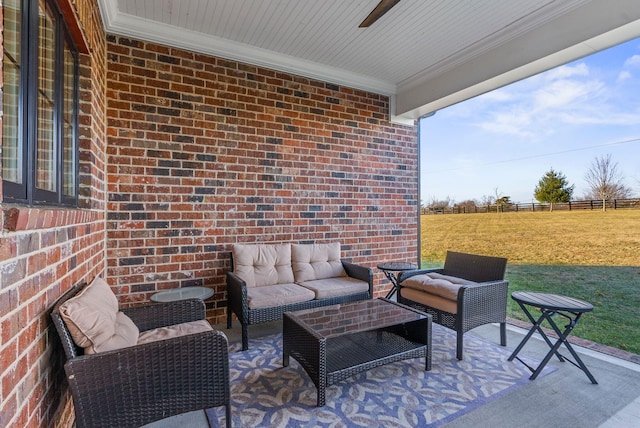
[51,278,231,428]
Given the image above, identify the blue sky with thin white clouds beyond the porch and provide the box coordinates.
[420,39,640,203]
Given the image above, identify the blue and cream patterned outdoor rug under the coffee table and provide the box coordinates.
[207,324,554,428]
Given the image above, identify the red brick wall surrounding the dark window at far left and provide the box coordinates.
[0,0,106,427]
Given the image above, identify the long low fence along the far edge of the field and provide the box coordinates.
[420,198,640,214]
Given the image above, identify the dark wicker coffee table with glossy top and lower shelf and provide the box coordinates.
[282,299,431,406]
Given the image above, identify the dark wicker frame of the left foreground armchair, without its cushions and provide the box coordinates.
[51,285,231,428]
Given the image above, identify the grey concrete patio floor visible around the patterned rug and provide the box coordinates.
[146,319,640,428]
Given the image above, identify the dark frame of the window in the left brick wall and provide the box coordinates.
[2,0,80,207]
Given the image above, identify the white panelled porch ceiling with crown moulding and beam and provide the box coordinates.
[99,0,640,122]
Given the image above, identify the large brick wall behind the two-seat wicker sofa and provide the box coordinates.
[107,36,418,323]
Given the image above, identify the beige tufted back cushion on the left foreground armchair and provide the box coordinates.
[60,277,138,353]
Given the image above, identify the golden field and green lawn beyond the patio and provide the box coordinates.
[421,210,640,354]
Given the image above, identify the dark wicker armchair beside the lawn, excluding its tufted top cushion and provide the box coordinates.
[398,251,509,360]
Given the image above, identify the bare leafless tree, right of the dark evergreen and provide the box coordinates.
[585,154,631,211]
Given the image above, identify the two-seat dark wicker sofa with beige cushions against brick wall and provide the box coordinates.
[227,242,373,350]
